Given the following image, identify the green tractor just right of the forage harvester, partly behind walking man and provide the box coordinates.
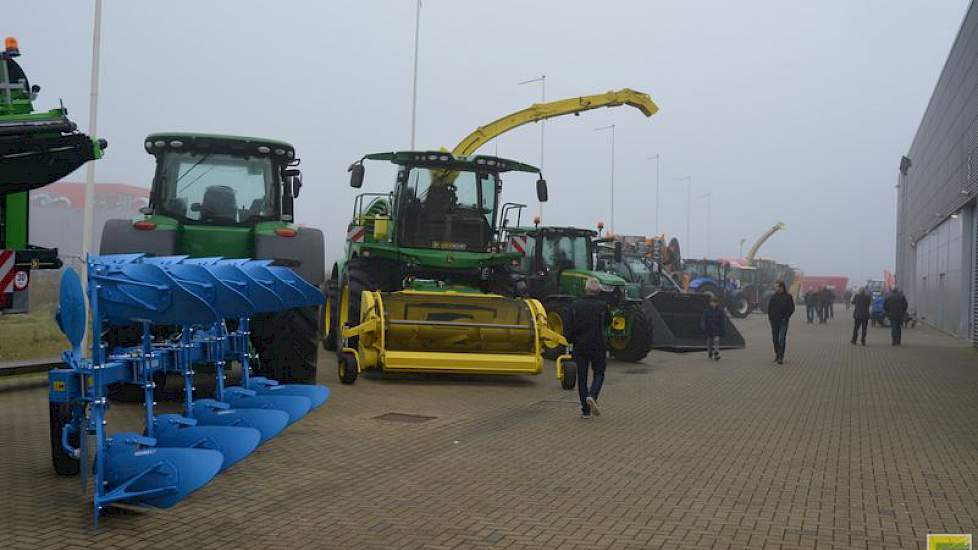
[503,222,652,363]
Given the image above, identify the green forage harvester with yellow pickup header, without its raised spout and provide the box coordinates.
[324,151,576,389]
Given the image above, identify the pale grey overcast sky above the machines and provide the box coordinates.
[7,0,968,282]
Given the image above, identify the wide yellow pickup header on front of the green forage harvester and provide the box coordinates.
[359,291,546,374]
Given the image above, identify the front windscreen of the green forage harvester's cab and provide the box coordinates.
[398,167,497,252]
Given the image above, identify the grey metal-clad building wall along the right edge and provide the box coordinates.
[896,0,978,345]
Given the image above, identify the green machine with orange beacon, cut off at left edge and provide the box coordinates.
[0,37,108,314]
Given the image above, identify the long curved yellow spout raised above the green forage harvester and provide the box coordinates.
[452,88,659,157]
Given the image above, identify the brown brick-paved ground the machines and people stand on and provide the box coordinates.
[0,315,978,550]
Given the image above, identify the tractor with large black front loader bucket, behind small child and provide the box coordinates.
[599,235,745,352]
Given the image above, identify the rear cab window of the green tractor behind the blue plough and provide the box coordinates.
[155,152,278,225]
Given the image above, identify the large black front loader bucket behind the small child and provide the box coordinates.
[642,292,745,352]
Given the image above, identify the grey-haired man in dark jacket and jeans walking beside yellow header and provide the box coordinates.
[564,278,608,419]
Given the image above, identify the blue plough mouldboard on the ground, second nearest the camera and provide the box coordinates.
[153,414,261,471]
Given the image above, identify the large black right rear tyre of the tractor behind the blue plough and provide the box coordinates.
[251,307,319,384]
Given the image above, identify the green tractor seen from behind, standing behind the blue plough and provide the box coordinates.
[100,132,325,383]
